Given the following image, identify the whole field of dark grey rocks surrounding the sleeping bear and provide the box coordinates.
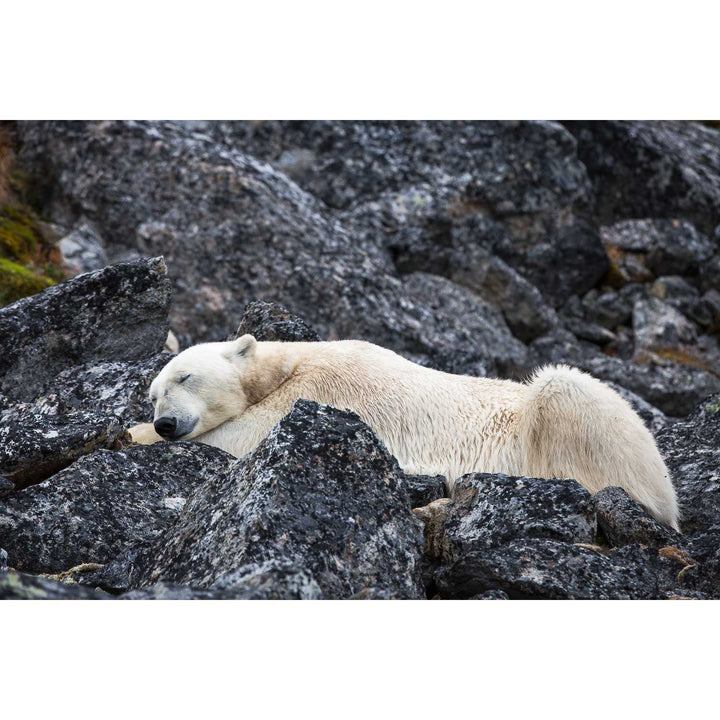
[0,121,720,598]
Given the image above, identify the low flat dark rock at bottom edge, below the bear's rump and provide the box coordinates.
[436,538,660,600]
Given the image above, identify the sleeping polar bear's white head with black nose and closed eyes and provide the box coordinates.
[150,335,257,440]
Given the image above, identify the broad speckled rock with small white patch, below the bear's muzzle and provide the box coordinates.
[0,442,235,573]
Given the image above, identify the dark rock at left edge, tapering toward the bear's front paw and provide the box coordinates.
[0,403,129,489]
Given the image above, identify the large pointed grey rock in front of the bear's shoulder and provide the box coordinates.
[132,400,424,598]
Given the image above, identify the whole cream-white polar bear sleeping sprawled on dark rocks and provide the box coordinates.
[131,335,678,530]
